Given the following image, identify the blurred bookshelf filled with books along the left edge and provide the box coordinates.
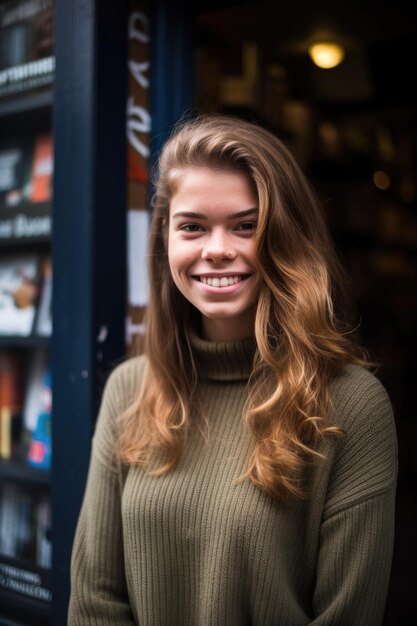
[0,0,54,625]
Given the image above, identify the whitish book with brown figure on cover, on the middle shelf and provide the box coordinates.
[0,253,40,337]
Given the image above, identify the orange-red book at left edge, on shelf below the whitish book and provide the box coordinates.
[0,350,23,459]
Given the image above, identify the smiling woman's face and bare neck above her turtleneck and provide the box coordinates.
[168,167,259,341]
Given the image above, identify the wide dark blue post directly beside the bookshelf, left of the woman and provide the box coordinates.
[51,0,127,626]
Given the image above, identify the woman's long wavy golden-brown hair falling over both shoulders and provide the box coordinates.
[118,114,368,497]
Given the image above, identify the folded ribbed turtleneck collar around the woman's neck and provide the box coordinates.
[190,333,256,381]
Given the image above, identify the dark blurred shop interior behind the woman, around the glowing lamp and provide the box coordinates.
[195,1,417,626]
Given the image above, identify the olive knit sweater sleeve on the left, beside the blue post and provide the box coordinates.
[68,359,145,626]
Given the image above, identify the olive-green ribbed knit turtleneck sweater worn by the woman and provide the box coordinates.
[68,338,397,626]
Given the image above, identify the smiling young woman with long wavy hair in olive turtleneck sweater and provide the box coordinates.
[69,115,397,626]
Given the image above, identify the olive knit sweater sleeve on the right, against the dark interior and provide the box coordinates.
[311,368,398,626]
